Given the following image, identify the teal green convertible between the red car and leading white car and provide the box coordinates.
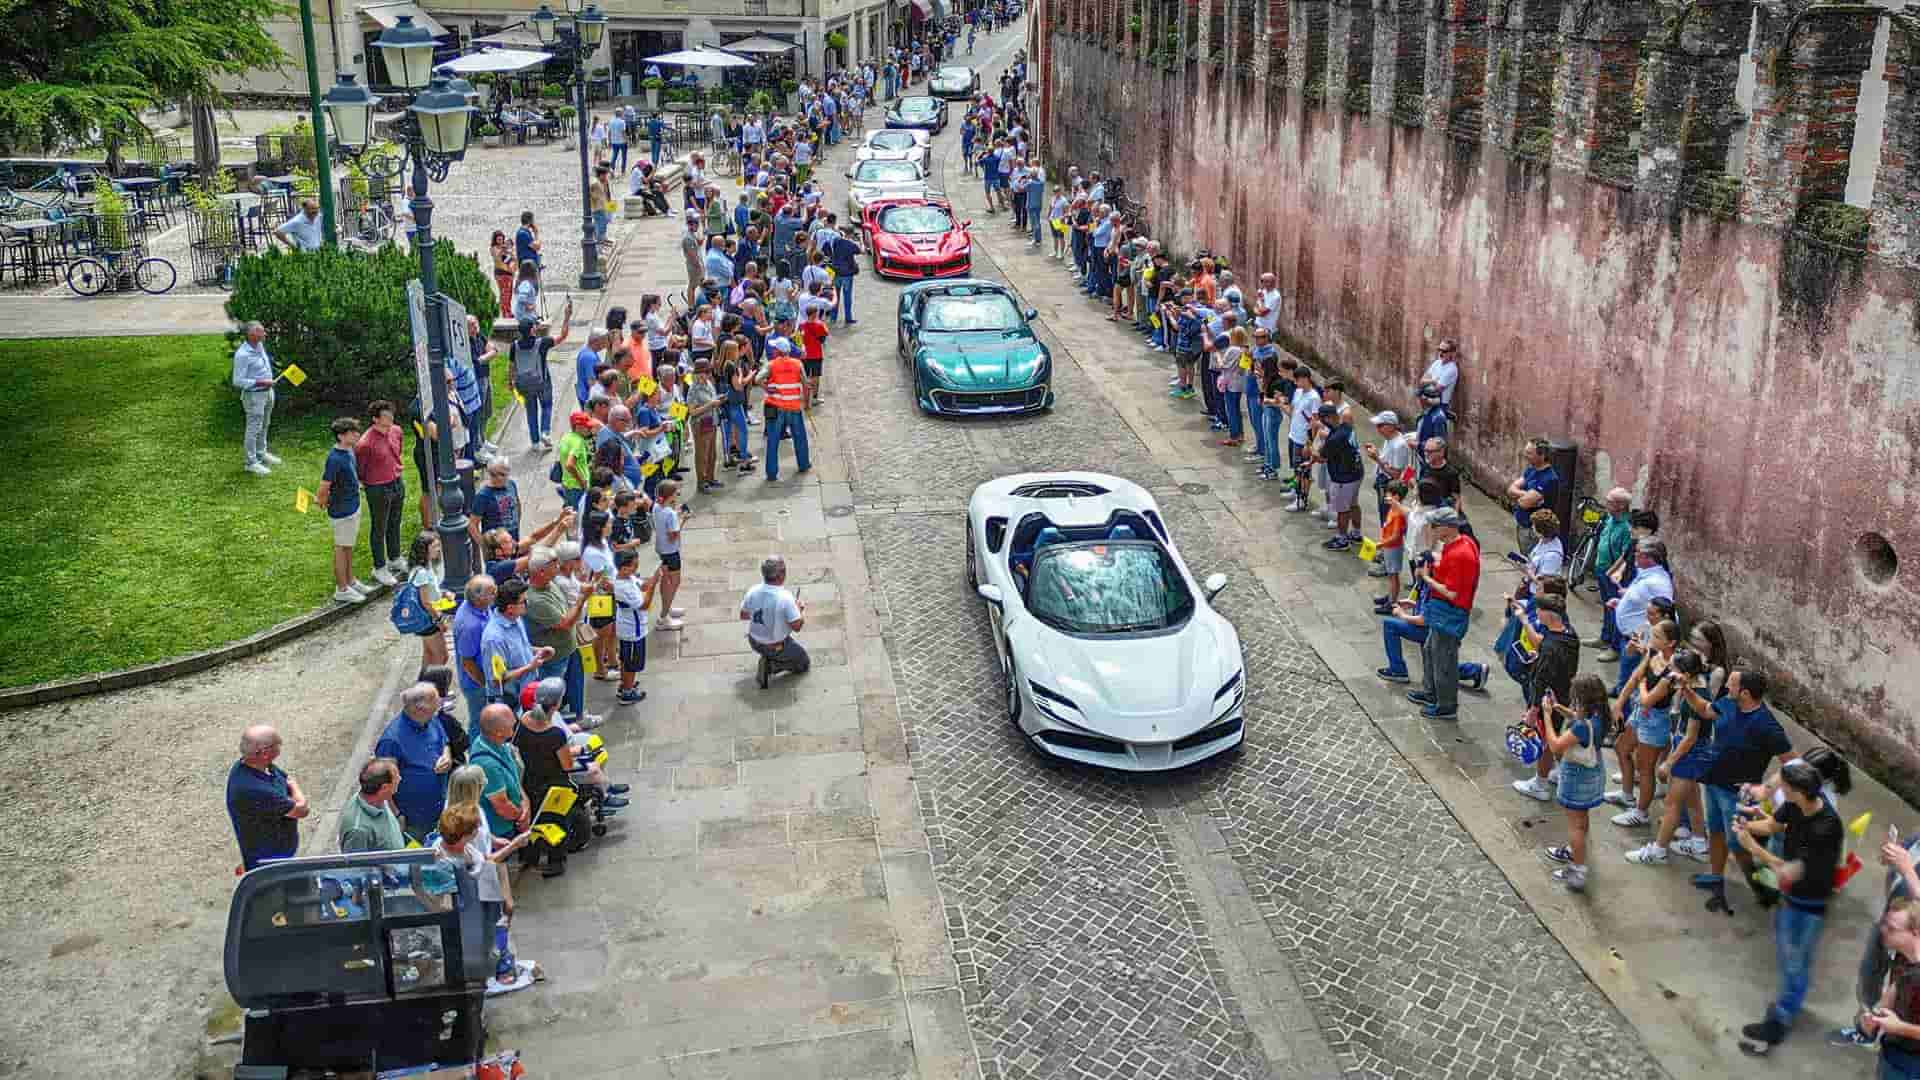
[899,277,1054,415]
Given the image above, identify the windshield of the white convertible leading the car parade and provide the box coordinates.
[1027,540,1194,634]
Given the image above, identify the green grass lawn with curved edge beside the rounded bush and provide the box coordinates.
[0,334,511,686]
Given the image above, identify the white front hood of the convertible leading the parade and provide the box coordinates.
[1020,607,1240,742]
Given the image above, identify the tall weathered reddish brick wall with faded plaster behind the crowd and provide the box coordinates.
[1039,0,1920,798]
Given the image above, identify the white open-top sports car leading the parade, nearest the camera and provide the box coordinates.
[966,473,1246,771]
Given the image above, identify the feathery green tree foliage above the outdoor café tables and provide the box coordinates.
[0,0,286,150]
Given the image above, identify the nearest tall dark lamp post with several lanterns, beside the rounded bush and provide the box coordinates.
[323,15,474,592]
